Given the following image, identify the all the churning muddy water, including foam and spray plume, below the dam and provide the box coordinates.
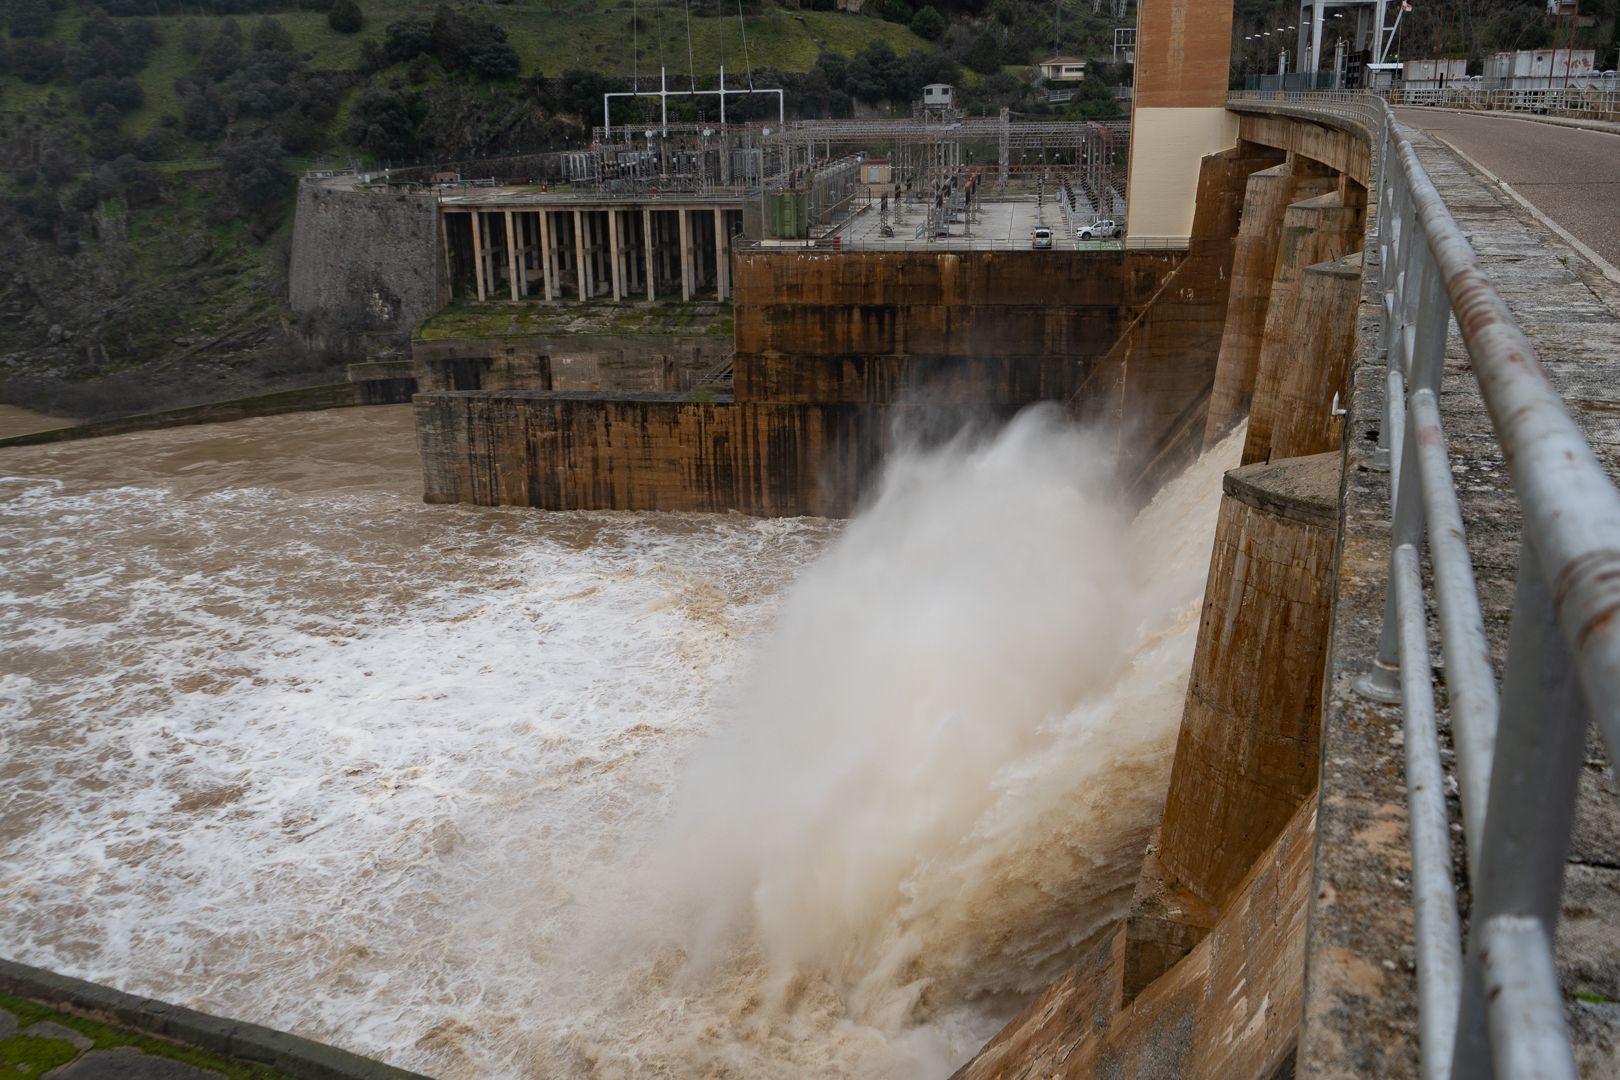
[0,410,1241,1078]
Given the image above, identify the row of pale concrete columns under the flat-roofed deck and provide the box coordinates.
[446,206,739,301]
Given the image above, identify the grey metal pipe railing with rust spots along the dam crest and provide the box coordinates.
[1231,94,1620,1080]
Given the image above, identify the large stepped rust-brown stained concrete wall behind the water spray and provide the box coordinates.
[416,250,1185,517]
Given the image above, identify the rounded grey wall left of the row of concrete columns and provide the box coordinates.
[287,180,450,345]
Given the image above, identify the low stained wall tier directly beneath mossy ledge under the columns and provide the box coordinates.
[411,334,732,392]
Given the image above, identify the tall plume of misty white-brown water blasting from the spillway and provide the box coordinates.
[550,410,1243,1075]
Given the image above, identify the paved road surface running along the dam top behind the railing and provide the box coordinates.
[1395,108,1620,267]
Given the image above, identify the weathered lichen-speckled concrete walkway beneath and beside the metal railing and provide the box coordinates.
[1298,116,1620,1077]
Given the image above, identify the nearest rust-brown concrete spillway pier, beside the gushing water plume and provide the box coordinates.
[1158,452,1340,908]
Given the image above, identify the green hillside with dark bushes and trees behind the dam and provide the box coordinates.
[0,0,1620,415]
